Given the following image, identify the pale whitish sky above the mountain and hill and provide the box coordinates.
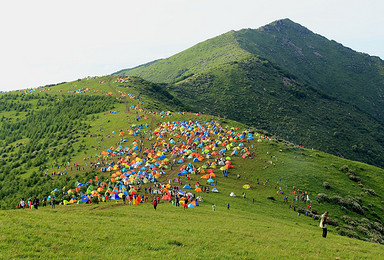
[0,0,384,91]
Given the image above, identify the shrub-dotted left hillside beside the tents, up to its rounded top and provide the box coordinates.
[0,77,182,209]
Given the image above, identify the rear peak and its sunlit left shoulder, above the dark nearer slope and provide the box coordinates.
[119,19,384,122]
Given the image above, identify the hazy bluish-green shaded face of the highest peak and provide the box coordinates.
[235,19,384,122]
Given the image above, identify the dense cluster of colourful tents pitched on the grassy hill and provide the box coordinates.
[43,117,274,207]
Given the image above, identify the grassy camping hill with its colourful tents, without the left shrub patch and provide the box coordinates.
[0,76,383,258]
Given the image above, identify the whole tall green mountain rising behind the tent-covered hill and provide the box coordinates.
[115,19,384,167]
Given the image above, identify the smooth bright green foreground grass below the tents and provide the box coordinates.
[0,197,384,259]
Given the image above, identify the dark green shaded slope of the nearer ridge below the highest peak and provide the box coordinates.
[170,55,384,167]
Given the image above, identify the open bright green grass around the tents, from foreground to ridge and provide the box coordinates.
[0,77,384,259]
